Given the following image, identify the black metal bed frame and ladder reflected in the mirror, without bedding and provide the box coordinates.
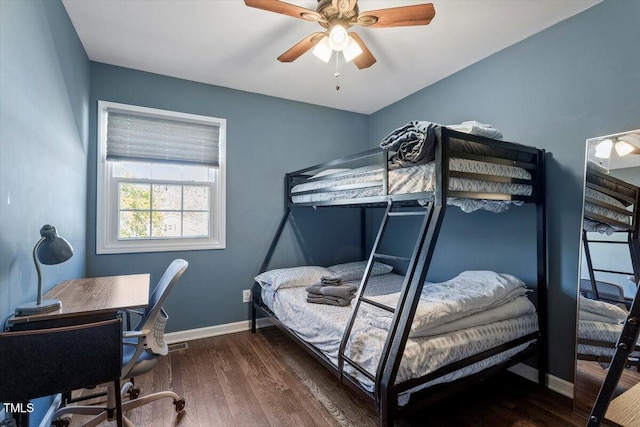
[578,170,640,427]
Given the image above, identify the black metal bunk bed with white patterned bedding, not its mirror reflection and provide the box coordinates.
[251,126,547,426]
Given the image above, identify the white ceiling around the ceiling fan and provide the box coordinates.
[63,0,601,113]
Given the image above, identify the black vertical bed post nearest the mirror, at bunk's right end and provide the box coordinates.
[536,150,549,388]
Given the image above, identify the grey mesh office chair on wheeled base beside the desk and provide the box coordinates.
[54,259,189,427]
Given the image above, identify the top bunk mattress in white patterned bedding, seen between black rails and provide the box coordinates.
[291,158,532,212]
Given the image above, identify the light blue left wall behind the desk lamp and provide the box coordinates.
[0,0,89,422]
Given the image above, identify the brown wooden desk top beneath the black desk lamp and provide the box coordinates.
[7,274,149,331]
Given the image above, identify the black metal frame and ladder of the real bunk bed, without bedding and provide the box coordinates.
[251,127,548,426]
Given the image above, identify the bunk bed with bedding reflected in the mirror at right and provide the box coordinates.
[577,160,640,427]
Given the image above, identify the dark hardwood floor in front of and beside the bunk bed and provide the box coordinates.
[71,328,585,427]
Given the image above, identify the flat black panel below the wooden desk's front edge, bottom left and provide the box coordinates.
[0,319,123,427]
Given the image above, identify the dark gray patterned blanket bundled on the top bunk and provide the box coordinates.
[380,120,437,167]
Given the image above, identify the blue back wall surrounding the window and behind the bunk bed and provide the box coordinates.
[87,63,368,331]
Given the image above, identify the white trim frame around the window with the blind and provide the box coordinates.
[96,101,227,255]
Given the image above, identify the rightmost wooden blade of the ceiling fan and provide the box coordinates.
[358,3,436,28]
